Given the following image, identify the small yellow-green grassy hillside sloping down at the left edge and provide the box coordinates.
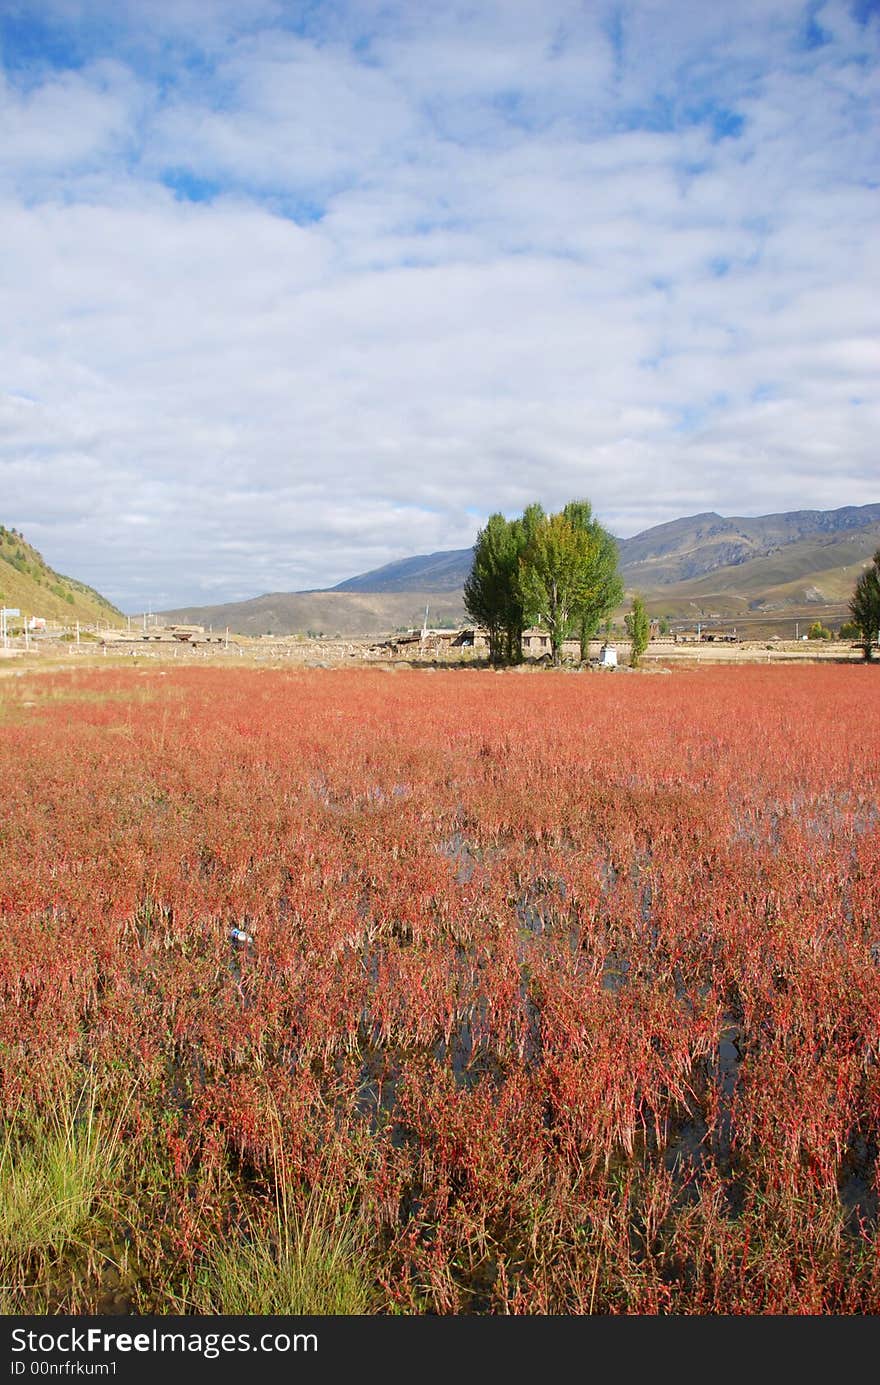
[0,525,125,625]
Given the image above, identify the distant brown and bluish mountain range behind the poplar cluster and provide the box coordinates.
[161,504,880,636]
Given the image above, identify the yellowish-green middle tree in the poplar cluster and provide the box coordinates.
[520,511,597,665]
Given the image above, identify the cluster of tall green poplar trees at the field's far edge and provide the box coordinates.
[464,500,624,663]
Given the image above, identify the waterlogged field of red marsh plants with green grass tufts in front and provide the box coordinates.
[0,666,880,1314]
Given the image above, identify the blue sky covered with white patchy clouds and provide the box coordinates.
[0,0,880,612]
